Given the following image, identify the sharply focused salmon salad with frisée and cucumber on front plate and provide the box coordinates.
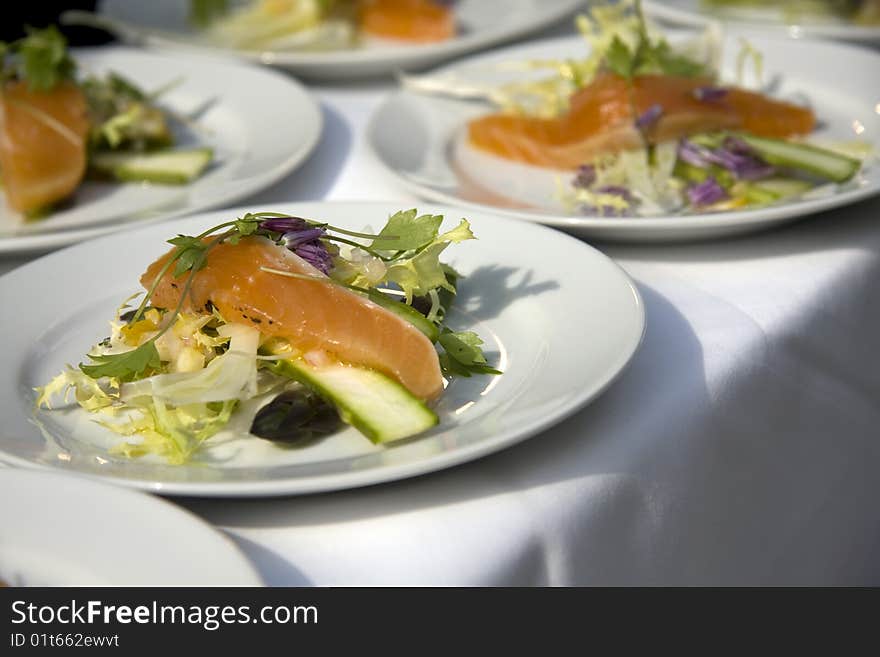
[36,210,500,463]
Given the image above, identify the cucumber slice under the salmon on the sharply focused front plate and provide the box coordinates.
[270,359,440,444]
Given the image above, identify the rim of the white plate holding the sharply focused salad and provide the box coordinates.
[0,200,647,498]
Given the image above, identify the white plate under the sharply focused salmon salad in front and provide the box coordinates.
[0,203,644,496]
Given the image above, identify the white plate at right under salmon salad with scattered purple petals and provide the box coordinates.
[367,34,880,240]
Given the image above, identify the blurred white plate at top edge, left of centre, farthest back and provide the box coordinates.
[91,0,583,79]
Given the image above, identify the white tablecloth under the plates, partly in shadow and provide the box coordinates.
[0,24,880,585]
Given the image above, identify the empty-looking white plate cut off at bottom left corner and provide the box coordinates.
[0,468,262,586]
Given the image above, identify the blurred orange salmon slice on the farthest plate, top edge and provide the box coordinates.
[358,0,455,43]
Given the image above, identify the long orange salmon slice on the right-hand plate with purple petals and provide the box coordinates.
[468,73,816,169]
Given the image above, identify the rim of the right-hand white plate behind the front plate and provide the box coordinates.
[364,30,880,242]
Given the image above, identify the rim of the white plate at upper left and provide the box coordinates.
[0,45,325,257]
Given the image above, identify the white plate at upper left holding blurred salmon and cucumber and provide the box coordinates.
[0,47,323,254]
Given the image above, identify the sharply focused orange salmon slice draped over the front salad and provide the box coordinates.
[141,237,443,400]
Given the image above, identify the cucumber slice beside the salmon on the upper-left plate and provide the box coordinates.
[89,148,214,185]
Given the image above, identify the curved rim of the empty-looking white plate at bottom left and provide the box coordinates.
[0,466,265,587]
